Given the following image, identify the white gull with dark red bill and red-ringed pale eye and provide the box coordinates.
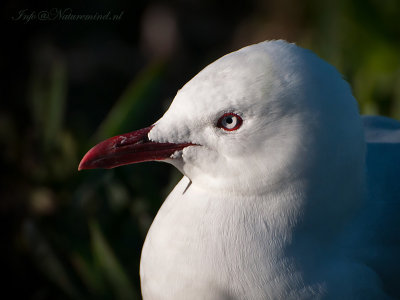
[79,41,400,300]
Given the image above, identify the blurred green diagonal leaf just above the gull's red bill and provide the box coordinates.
[95,61,165,140]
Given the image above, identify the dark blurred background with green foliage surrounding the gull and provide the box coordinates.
[0,0,400,300]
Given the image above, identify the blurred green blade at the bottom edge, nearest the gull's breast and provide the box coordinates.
[89,221,139,300]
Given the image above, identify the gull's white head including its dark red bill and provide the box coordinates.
[79,41,364,199]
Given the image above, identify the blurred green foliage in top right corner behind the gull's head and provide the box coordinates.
[300,0,400,119]
